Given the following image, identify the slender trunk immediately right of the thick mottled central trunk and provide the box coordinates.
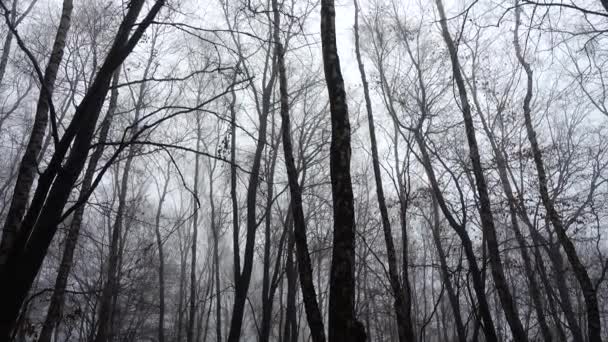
[354,0,415,342]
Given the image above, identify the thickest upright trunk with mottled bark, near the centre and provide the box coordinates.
[321,0,366,342]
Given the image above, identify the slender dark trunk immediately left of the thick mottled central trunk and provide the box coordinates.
[272,0,325,342]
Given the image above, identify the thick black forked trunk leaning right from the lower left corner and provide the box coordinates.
[0,0,165,341]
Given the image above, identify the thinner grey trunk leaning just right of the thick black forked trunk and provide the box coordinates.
[38,73,120,342]
